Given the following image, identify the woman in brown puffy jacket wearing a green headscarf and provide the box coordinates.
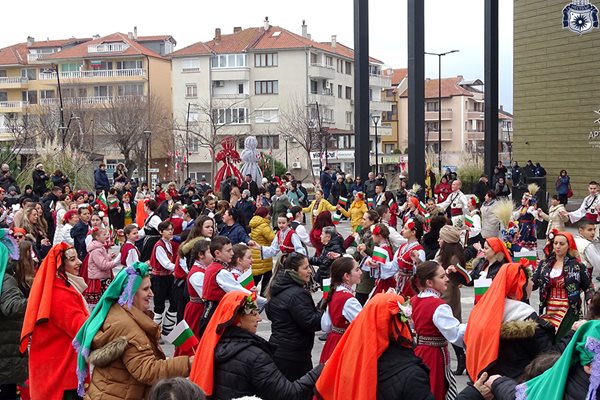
[73,262,194,399]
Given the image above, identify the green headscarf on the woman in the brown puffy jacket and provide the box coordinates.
[73,262,149,397]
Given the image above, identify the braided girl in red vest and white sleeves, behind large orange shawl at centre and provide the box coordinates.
[319,257,362,364]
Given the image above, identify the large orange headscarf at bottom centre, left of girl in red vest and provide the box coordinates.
[316,293,412,400]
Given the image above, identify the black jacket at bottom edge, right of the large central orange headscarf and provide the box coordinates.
[377,342,434,400]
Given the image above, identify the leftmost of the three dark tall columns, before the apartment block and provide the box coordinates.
[354,0,371,182]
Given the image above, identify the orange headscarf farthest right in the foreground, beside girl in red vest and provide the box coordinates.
[465,263,528,381]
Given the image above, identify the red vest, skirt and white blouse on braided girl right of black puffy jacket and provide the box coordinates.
[319,284,362,364]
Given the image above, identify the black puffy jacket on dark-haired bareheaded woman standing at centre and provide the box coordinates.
[266,271,321,360]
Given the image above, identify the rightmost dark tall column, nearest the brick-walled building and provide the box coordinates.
[484,0,498,177]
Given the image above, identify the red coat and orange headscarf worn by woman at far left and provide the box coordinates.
[20,243,89,400]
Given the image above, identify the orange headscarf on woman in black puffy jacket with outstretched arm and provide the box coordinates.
[190,291,248,396]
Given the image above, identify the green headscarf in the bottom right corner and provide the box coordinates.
[516,320,600,400]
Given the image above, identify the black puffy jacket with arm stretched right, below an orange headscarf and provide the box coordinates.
[211,326,323,400]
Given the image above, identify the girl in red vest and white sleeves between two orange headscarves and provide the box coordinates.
[411,261,466,400]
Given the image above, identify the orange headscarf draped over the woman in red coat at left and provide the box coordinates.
[20,242,72,354]
